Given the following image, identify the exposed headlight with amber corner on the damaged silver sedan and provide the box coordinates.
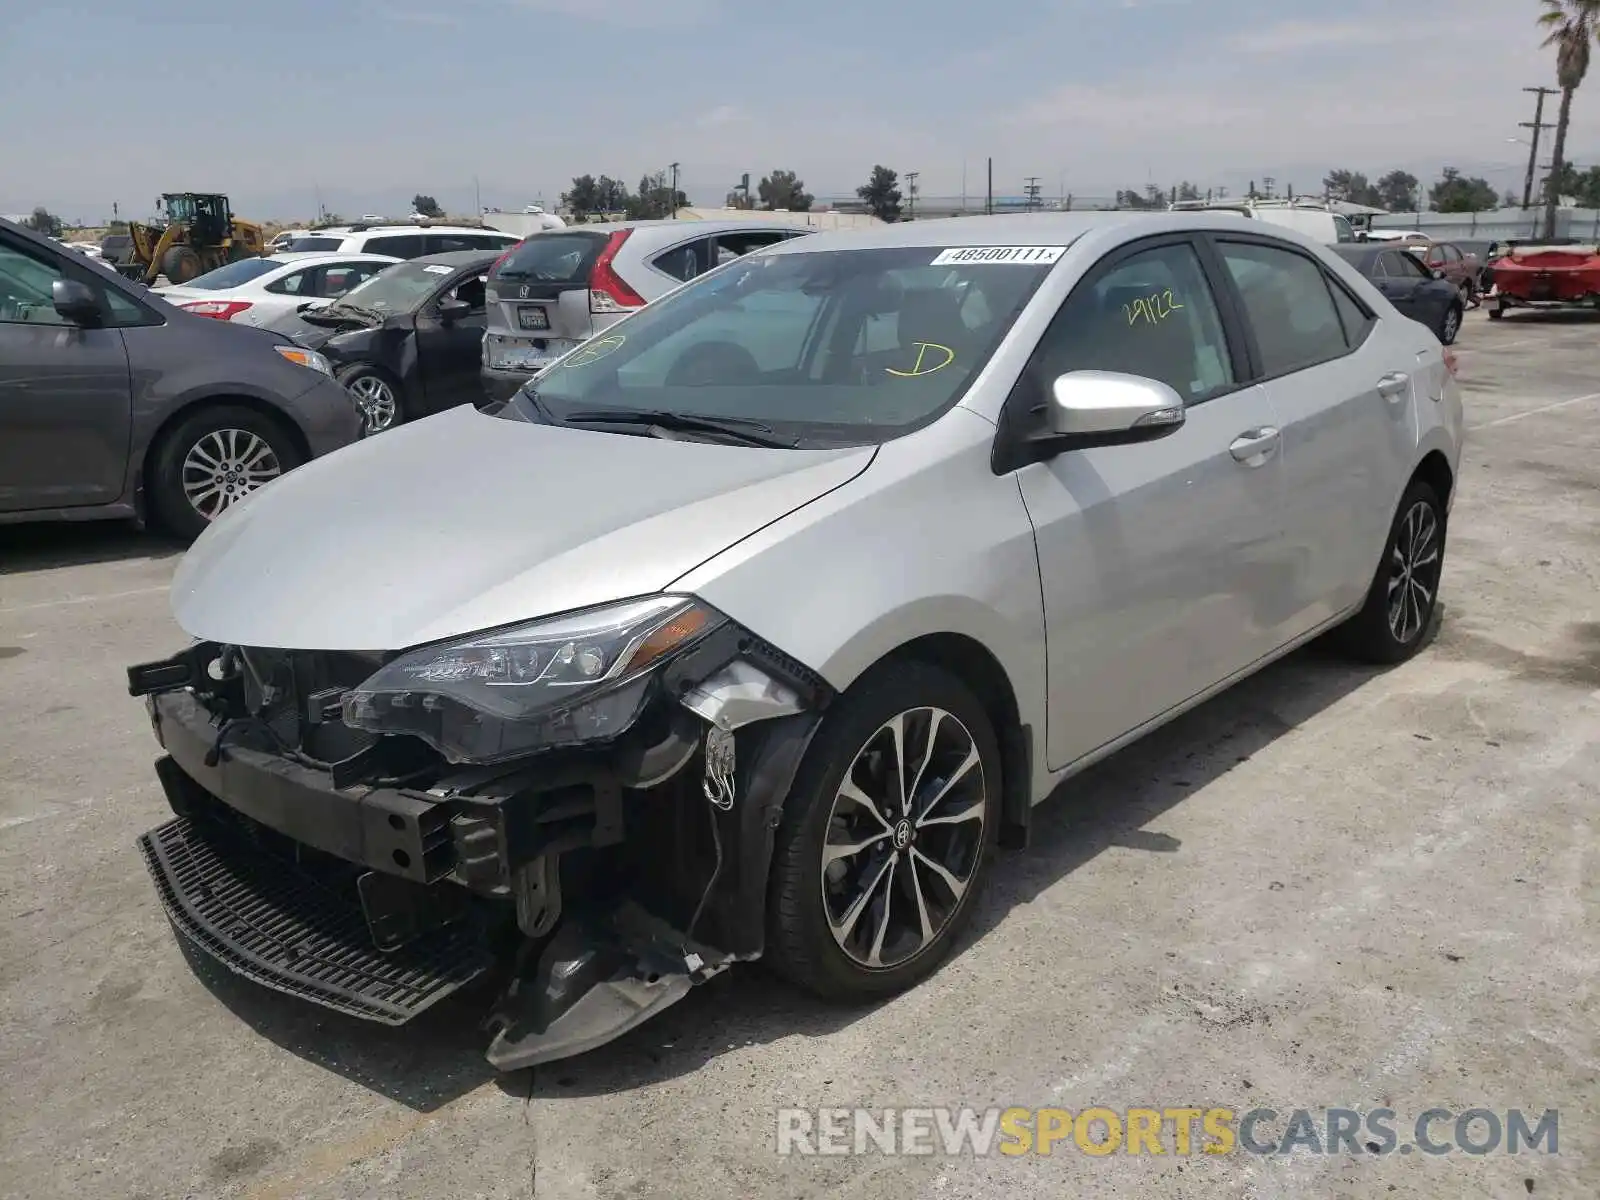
[342,595,725,763]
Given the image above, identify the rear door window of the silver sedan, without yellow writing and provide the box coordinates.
[1218,242,1350,378]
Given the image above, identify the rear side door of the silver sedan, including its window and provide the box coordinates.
[1213,234,1426,630]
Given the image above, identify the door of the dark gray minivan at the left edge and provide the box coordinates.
[0,232,133,512]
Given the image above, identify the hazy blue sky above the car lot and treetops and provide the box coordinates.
[0,0,1600,219]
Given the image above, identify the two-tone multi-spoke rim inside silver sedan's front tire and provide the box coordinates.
[821,707,989,970]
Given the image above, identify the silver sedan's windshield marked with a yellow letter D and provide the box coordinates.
[507,246,1059,445]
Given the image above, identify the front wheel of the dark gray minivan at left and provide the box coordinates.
[146,403,304,539]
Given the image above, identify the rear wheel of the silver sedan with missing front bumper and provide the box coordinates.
[1336,480,1446,666]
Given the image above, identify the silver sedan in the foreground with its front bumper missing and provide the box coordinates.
[130,213,1462,1067]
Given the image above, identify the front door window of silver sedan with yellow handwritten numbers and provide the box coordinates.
[1034,243,1234,403]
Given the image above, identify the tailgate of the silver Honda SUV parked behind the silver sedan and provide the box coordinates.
[485,229,608,370]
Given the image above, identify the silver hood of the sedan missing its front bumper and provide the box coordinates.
[171,406,875,650]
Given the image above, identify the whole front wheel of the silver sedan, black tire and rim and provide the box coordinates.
[766,662,1002,1002]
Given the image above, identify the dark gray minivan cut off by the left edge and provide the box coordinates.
[0,219,362,538]
